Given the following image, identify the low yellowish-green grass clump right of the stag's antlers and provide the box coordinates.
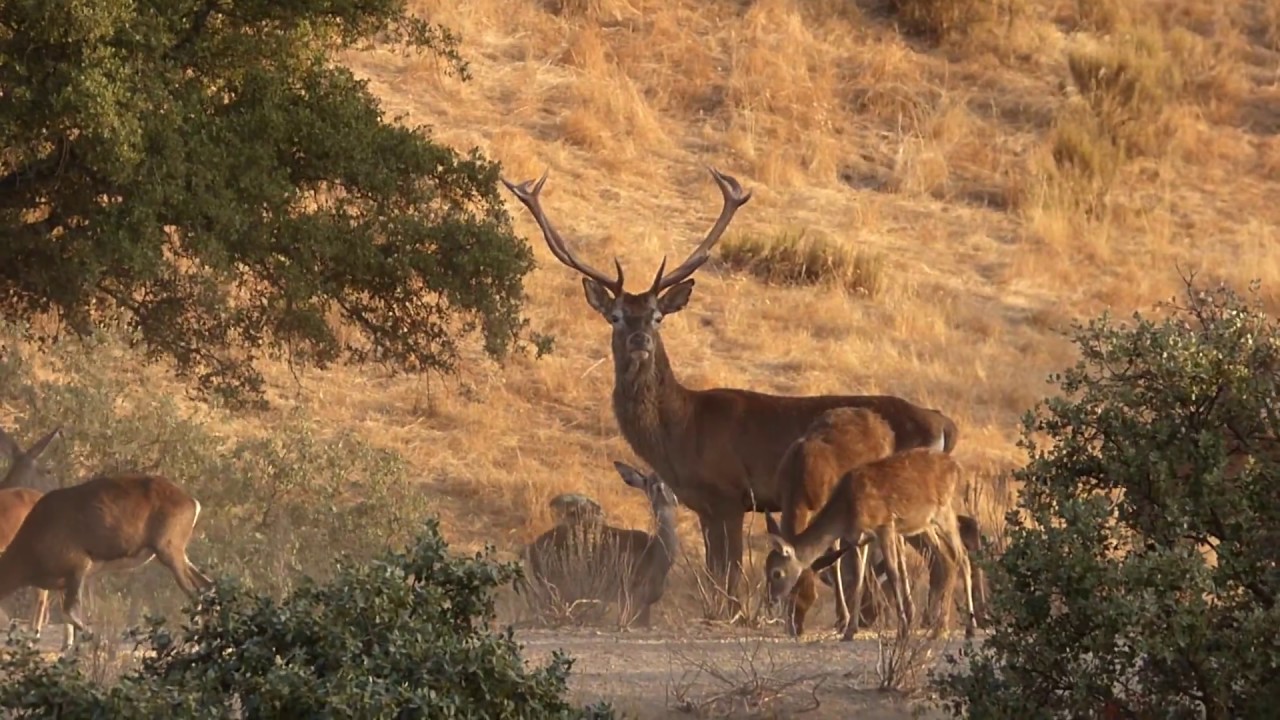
[719,231,884,297]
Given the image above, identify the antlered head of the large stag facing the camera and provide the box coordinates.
[502,168,751,373]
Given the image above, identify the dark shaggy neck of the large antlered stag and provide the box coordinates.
[613,338,691,476]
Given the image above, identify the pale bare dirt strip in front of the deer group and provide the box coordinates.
[516,625,963,720]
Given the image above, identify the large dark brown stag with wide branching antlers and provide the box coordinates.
[502,168,956,615]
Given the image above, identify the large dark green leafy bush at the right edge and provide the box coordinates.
[938,282,1280,719]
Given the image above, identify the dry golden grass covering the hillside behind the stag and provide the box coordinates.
[10,0,1280,617]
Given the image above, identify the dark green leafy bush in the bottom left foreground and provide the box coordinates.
[0,520,613,720]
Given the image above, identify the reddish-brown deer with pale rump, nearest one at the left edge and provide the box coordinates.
[0,473,212,648]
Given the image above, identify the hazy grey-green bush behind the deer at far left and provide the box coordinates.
[0,319,429,609]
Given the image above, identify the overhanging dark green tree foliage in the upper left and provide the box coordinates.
[0,0,532,398]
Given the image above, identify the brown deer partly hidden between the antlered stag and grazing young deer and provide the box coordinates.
[768,407,893,639]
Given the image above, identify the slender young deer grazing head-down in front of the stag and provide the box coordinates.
[764,448,977,637]
